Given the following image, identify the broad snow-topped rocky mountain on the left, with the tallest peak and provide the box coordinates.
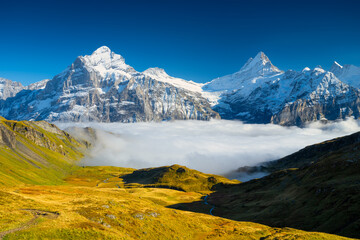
[0,47,219,122]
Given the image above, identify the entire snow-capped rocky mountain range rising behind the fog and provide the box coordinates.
[0,46,360,126]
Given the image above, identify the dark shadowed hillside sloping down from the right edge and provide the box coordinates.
[204,133,360,238]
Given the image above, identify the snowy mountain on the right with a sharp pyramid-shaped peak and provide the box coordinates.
[203,52,360,126]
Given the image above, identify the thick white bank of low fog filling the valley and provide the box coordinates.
[57,119,360,180]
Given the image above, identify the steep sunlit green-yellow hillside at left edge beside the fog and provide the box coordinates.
[0,118,87,186]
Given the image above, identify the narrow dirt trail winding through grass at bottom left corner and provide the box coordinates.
[0,209,60,239]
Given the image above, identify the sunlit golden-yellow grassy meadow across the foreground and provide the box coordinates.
[0,167,352,239]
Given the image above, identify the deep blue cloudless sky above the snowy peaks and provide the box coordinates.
[0,0,360,85]
